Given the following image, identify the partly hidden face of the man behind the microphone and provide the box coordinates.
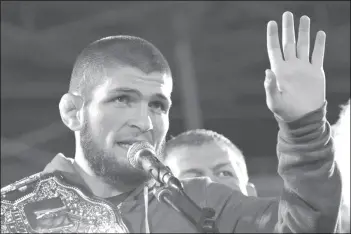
[165,143,247,195]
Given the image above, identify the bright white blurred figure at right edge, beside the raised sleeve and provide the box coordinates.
[333,99,350,233]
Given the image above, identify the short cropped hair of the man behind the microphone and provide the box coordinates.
[162,129,248,181]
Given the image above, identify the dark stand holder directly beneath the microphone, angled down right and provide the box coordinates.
[153,186,219,233]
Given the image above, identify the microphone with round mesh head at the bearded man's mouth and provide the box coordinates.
[127,142,183,191]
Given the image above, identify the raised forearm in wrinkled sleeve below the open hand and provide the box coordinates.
[276,104,341,232]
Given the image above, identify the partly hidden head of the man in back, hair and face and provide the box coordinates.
[163,129,257,196]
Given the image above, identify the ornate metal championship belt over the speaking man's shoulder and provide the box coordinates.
[1,173,128,233]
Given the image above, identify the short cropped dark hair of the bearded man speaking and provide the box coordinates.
[69,35,171,96]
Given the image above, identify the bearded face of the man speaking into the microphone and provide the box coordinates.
[80,67,172,185]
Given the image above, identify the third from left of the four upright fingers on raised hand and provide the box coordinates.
[297,15,310,61]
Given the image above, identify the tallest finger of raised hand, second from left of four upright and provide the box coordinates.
[282,11,296,60]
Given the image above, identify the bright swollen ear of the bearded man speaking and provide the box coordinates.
[59,93,84,131]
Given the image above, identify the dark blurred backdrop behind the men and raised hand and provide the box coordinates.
[1,1,350,185]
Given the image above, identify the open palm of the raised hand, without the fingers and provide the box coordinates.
[267,59,325,121]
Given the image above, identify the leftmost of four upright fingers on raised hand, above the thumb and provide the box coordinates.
[267,21,283,67]
